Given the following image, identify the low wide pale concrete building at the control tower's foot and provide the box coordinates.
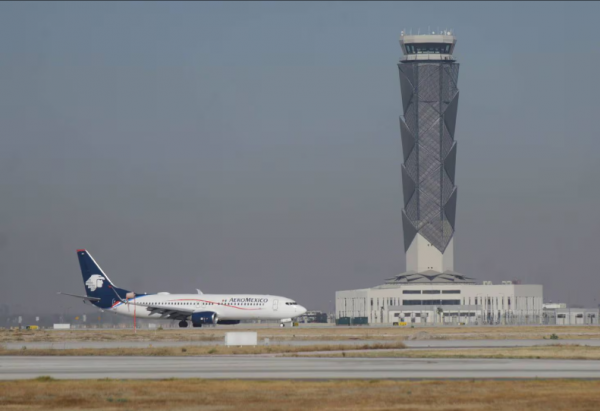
[335,283,544,324]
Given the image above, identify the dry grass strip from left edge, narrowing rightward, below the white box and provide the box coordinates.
[0,341,404,357]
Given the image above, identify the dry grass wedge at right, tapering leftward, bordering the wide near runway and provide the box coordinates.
[315,345,600,360]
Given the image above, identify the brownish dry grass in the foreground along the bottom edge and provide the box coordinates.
[0,379,600,411]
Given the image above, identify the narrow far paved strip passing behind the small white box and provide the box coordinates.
[7,339,600,350]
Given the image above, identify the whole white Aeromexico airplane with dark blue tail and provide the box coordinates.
[58,249,306,328]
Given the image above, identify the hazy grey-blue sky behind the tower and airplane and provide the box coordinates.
[0,2,600,312]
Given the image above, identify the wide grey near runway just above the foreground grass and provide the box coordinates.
[0,355,600,380]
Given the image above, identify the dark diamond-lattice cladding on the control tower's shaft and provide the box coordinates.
[398,61,459,253]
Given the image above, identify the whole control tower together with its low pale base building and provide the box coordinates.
[335,32,543,324]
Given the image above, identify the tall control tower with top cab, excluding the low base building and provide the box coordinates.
[398,31,459,274]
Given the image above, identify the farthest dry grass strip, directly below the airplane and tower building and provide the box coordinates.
[0,325,600,343]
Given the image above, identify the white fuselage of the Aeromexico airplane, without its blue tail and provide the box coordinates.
[109,293,306,320]
